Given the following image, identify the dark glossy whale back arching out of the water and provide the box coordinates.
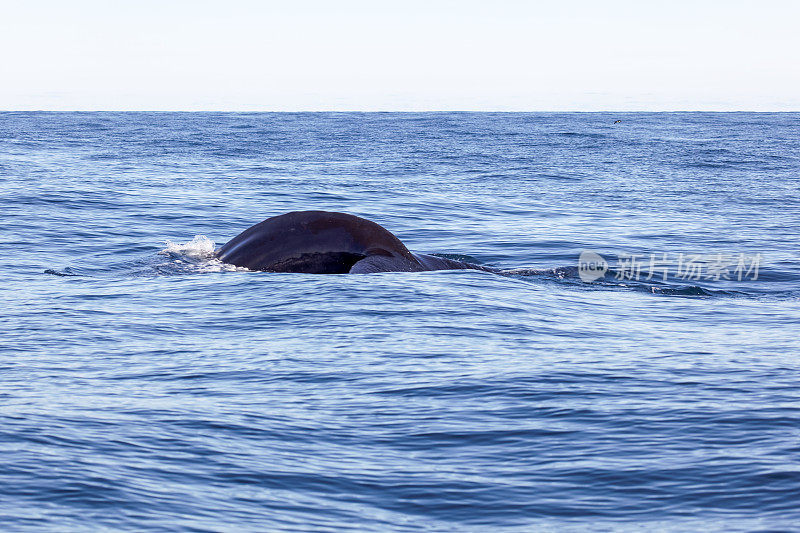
[217,211,493,274]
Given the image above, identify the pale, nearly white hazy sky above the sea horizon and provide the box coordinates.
[0,0,800,111]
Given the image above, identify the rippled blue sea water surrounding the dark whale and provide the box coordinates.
[0,113,800,532]
